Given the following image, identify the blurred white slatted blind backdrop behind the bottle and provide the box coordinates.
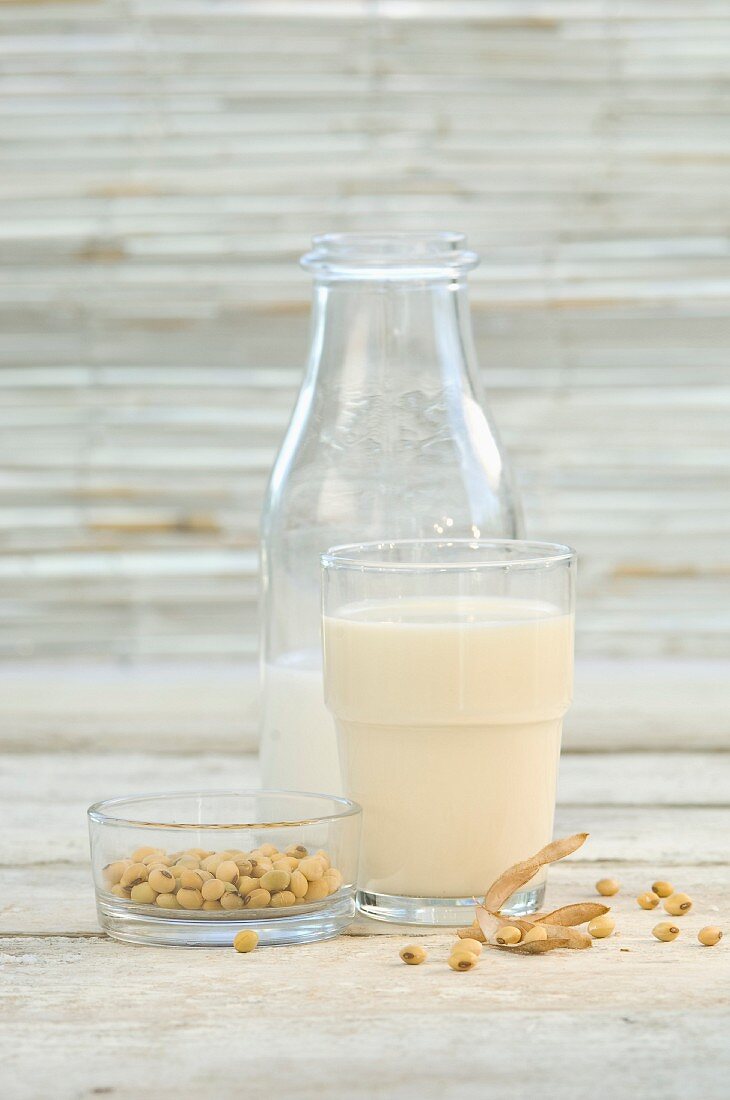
[0,0,730,661]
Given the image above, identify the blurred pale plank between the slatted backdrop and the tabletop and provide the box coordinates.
[0,655,730,756]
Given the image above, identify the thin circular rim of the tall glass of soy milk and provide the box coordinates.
[320,538,577,573]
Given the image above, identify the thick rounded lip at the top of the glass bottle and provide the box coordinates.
[301,232,479,279]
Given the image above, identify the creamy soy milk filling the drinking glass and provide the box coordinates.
[323,596,573,898]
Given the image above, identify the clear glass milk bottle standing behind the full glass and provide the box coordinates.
[261,233,521,794]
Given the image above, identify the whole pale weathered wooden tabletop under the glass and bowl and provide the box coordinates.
[0,734,730,1100]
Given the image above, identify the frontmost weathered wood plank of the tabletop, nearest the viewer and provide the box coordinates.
[0,928,730,1100]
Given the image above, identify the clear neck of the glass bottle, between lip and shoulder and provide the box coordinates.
[308,278,482,398]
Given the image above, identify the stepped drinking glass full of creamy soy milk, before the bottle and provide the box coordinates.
[321,539,576,924]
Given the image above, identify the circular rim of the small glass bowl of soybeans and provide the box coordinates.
[87,788,363,831]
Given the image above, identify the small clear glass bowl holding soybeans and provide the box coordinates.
[88,791,362,947]
